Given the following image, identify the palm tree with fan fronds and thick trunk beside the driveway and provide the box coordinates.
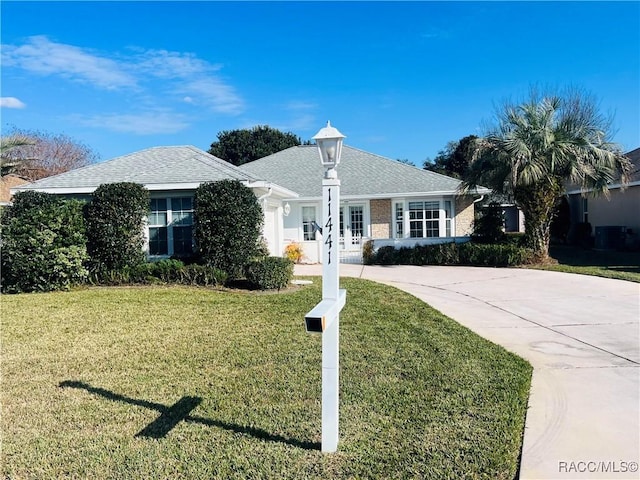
[462,92,631,261]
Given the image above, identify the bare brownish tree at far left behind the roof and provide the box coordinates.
[1,129,98,182]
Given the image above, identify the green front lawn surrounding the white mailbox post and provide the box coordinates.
[0,278,531,480]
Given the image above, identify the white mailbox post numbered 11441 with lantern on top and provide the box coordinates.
[305,122,346,452]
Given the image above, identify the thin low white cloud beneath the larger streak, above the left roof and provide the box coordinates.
[75,111,189,135]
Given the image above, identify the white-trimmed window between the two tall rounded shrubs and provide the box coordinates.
[148,197,193,256]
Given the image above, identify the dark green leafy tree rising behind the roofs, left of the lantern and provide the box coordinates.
[209,125,311,165]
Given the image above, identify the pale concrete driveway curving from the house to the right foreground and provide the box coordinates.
[295,264,640,480]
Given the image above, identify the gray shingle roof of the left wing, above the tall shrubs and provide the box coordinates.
[23,145,258,190]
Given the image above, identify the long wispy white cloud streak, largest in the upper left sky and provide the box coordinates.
[2,36,245,115]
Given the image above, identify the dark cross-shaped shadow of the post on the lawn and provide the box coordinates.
[59,380,321,450]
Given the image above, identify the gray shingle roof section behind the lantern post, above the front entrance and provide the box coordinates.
[240,145,460,198]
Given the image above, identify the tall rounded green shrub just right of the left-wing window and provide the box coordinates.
[194,180,263,279]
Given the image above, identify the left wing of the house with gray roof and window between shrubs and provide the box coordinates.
[12,145,296,259]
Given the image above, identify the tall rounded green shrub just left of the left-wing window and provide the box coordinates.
[85,182,150,276]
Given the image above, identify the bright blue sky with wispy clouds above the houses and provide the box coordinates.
[0,0,640,166]
